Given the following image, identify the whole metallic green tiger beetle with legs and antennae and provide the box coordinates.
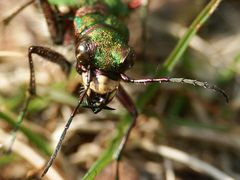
[5,0,228,179]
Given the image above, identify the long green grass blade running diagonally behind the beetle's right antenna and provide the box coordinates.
[83,0,221,179]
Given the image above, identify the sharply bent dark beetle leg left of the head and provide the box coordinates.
[6,46,71,153]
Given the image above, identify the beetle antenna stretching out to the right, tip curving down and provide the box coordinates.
[121,74,229,103]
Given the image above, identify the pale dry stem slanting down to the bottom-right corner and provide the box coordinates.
[140,140,234,180]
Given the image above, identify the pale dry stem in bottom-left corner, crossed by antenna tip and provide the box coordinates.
[0,129,64,180]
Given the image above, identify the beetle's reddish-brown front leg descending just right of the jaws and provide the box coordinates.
[114,85,138,179]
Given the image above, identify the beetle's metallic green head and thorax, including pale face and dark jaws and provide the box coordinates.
[74,3,134,113]
